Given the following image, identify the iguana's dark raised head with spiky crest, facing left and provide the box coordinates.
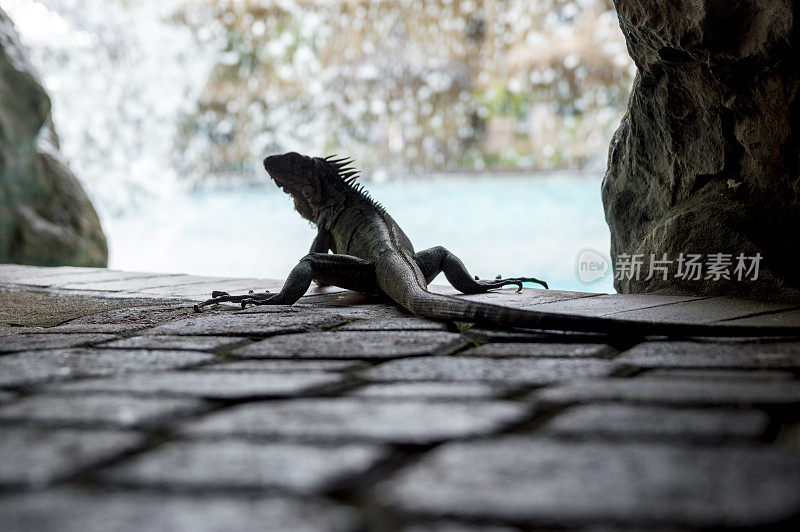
[264,152,368,223]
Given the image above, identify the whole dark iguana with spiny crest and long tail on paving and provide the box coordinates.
[195,153,800,336]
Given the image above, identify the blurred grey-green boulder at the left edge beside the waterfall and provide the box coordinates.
[0,10,108,266]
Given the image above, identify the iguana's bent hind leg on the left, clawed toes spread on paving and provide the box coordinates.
[194,253,378,311]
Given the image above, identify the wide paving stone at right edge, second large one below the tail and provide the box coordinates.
[533,377,800,407]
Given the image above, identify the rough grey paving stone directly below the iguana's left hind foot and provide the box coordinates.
[148,305,347,336]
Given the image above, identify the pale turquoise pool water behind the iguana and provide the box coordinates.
[104,174,613,292]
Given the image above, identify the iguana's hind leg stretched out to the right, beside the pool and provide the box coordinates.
[414,246,547,294]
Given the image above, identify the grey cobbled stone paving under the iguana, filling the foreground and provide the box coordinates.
[0,265,800,531]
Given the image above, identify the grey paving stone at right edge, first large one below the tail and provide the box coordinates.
[618,341,800,369]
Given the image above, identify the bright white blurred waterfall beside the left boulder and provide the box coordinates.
[0,0,217,221]
